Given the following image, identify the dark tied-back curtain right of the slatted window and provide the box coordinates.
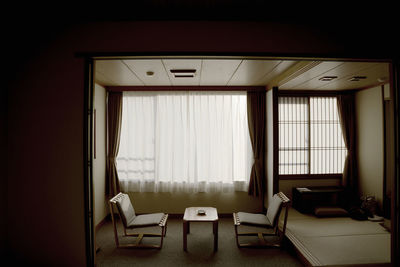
[337,94,358,196]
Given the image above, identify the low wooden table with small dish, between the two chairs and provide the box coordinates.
[183,207,218,251]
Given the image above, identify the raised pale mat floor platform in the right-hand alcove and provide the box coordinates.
[280,208,390,266]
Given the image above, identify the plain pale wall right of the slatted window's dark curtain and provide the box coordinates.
[355,86,384,208]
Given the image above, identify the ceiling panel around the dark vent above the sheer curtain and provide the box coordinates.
[162,59,202,86]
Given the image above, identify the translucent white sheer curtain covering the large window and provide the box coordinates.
[117,91,253,192]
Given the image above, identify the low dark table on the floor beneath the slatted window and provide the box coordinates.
[292,186,346,214]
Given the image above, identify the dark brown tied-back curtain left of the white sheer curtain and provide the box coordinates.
[106,92,122,197]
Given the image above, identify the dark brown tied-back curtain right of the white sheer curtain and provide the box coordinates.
[247,91,266,199]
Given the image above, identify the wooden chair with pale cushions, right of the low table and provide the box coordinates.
[233,192,290,248]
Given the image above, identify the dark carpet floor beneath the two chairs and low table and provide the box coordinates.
[96,218,302,267]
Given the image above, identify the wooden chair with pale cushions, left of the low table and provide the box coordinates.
[109,193,168,249]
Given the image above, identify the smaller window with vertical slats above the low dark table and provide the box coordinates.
[278,96,347,175]
